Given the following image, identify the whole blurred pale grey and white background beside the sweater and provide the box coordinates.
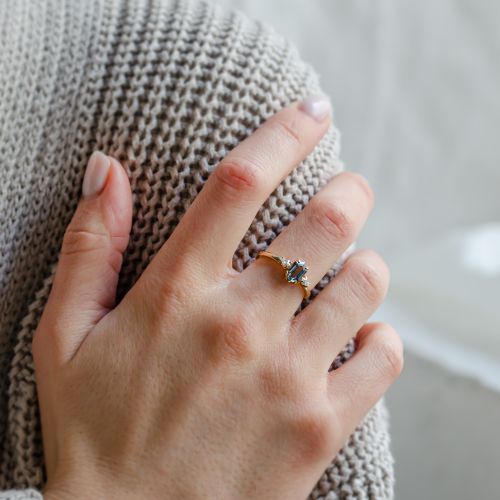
[216,0,500,500]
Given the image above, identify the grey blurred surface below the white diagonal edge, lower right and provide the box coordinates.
[386,351,500,500]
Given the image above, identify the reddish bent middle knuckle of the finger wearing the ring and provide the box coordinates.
[309,198,354,246]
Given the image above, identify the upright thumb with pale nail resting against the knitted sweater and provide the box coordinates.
[37,152,132,364]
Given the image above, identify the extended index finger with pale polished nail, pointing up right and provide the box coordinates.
[145,96,330,286]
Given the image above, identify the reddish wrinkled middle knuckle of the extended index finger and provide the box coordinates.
[216,157,265,200]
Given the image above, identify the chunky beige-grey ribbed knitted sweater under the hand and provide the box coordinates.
[0,0,393,500]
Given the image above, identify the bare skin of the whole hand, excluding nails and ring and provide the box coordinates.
[33,103,403,500]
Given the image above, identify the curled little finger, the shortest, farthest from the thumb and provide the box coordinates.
[327,323,403,439]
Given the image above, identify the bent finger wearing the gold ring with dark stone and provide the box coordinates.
[243,172,373,310]
